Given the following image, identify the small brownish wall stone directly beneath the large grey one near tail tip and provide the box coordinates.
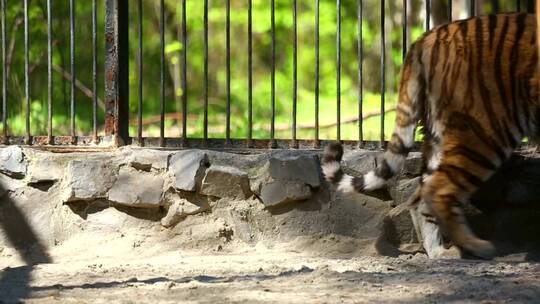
[261,180,311,207]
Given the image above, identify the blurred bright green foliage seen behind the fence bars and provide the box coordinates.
[2,0,468,140]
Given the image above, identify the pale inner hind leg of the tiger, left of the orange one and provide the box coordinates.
[408,185,461,259]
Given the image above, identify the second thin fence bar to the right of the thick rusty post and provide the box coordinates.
[159,0,165,147]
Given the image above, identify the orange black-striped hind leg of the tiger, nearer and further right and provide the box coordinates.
[421,129,510,258]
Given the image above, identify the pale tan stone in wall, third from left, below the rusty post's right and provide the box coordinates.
[108,167,163,207]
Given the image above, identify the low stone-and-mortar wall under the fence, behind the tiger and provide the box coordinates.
[0,146,540,255]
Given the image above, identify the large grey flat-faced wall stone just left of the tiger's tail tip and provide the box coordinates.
[267,155,321,188]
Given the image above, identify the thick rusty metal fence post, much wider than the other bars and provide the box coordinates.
[105,0,129,145]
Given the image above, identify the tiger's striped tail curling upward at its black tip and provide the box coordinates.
[322,45,425,192]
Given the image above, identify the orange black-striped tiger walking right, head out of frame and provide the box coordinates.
[322,13,540,259]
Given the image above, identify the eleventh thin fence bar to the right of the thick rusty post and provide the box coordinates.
[357,0,362,148]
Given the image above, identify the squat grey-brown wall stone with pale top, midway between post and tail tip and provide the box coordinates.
[201,165,252,199]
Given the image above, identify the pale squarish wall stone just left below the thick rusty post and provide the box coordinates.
[64,159,117,202]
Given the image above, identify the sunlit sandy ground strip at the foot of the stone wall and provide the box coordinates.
[0,242,540,303]
